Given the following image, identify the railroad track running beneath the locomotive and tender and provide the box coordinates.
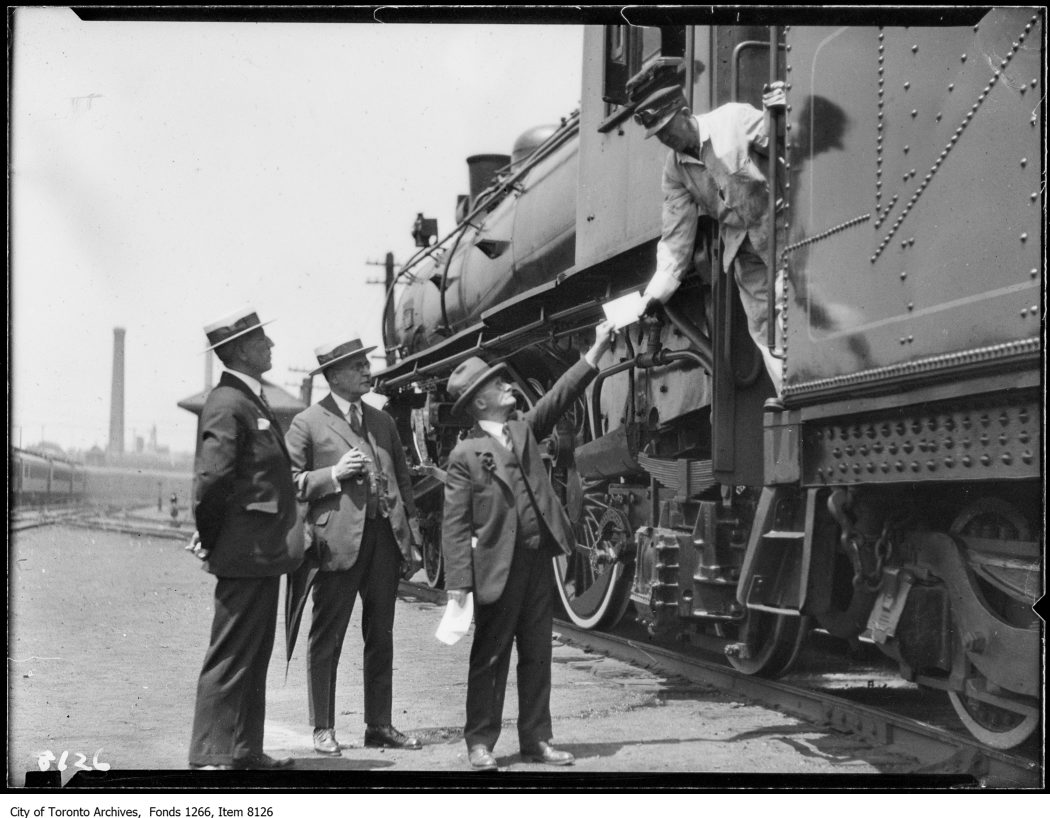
[401,582,1044,790]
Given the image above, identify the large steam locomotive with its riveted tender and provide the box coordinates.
[376,8,1045,748]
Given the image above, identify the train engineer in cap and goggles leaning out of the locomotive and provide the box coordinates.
[631,65,784,394]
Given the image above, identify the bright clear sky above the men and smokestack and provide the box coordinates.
[9,7,583,450]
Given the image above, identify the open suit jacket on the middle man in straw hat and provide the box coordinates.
[285,395,416,571]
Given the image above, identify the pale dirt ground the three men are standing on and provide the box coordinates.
[7,518,915,788]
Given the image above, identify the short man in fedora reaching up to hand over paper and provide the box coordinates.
[441,321,612,771]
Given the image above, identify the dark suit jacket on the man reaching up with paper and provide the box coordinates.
[441,359,597,605]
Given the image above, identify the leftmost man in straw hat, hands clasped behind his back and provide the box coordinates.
[189,309,302,770]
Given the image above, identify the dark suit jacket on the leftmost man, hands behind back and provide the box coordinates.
[193,372,302,576]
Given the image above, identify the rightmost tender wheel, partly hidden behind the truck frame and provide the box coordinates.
[948,497,1040,750]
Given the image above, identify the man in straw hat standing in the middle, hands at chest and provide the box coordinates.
[286,338,421,756]
